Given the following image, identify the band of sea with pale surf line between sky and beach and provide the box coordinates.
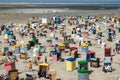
[0,0,120,10]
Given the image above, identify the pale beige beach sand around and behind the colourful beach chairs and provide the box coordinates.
[0,4,120,80]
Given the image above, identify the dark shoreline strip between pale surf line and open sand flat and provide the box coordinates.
[0,4,120,10]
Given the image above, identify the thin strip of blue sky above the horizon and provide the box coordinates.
[0,0,120,3]
